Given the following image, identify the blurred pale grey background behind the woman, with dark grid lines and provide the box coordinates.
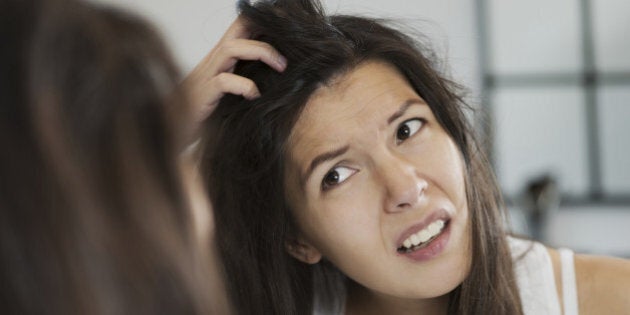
[93,0,630,257]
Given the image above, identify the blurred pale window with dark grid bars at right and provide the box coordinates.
[477,0,630,205]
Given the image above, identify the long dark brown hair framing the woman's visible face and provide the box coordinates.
[203,0,522,314]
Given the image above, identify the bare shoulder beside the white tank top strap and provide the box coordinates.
[575,254,630,315]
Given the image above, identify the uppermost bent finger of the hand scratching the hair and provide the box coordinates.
[216,39,287,72]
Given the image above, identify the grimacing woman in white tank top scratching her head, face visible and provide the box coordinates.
[202,0,630,314]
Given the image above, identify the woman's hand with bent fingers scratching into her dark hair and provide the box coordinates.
[183,18,287,125]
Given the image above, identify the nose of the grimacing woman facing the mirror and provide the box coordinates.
[379,154,428,213]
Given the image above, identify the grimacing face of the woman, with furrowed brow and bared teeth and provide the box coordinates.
[286,62,471,299]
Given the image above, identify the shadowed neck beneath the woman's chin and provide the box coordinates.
[345,281,449,315]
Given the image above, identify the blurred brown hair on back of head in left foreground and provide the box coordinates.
[0,0,215,314]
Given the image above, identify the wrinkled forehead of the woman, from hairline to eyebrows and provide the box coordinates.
[287,61,422,179]
